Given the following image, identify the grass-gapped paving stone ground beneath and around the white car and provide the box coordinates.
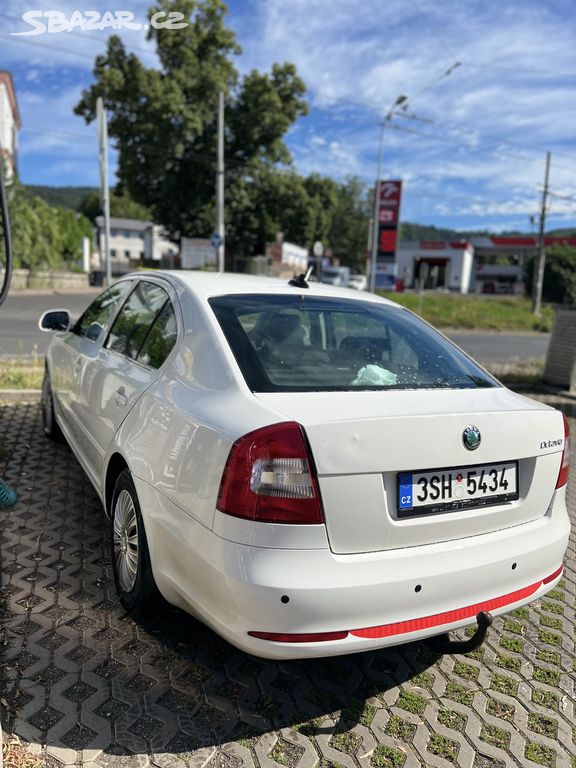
[0,398,576,768]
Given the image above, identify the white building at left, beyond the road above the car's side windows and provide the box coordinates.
[96,216,178,275]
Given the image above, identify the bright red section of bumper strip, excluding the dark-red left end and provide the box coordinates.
[350,566,563,638]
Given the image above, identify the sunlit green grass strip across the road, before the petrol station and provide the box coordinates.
[390,293,553,331]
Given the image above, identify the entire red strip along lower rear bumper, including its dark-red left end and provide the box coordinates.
[248,565,564,643]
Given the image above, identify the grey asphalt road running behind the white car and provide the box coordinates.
[0,288,550,364]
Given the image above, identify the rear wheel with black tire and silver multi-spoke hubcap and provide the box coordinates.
[110,469,159,616]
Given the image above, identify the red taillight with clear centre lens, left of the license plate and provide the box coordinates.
[218,421,324,524]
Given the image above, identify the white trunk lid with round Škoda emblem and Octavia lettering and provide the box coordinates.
[257,388,564,554]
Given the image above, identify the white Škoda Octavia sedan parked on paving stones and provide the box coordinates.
[40,271,569,659]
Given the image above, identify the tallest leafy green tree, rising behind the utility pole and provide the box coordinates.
[75,0,307,253]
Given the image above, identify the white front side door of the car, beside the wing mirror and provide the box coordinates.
[49,280,134,460]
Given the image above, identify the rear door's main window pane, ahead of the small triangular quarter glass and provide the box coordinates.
[104,280,168,359]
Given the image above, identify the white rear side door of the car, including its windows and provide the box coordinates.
[73,279,178,488]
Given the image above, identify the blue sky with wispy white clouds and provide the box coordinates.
[0,0,576,233]
